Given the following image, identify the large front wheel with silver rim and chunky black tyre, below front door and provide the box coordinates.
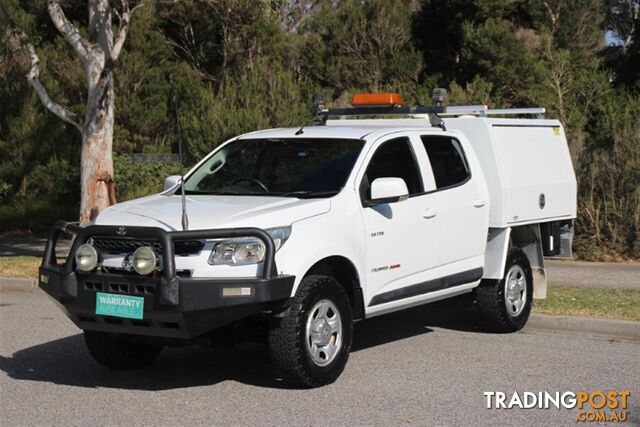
[269,275,353,387]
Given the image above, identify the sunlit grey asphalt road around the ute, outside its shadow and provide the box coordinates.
[0,291,640,426]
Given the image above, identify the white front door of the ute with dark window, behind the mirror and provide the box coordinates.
[359,135,441,306]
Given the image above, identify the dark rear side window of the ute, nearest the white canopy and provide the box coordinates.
[420,135,470,189]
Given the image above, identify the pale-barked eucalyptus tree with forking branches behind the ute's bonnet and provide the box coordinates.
[0,0,143,223]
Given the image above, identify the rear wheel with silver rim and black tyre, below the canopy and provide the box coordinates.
[476,249,533,332]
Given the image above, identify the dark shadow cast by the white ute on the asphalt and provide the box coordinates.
[0,299,481,391]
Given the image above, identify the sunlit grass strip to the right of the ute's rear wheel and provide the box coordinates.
[533,286,640,320]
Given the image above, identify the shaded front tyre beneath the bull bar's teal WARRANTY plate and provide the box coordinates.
[84,331,162,369]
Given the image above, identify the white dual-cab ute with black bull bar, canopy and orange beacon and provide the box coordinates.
[39,94,576,387]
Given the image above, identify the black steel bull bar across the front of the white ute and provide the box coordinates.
[39,222,295,339]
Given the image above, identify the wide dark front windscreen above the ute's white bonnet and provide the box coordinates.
[185,138,364,197]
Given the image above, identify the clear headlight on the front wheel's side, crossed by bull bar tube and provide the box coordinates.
[209,227,291,265]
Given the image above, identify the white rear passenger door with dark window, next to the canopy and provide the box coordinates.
[420,135,489,278]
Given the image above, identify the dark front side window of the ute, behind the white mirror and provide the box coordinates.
[360,137,424,200]
